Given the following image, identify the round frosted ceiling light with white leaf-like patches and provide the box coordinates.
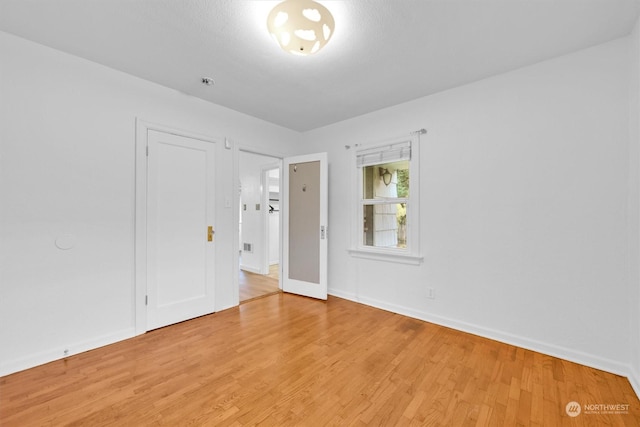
[267,0,335,55]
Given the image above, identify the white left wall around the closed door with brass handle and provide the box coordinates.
[0,33,300,375]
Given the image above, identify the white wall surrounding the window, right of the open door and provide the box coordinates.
[304,38,638,374]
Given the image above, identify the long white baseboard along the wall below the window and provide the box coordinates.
[330,290,640,388]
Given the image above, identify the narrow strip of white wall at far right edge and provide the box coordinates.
[628,16,640,396]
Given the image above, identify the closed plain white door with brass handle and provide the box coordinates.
[147,130,215,330]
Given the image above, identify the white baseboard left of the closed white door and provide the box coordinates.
[0,328,135,376]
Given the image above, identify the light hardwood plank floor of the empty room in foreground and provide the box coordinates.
[0,293,640,427]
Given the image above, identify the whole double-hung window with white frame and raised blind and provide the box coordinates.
[350,140,421,263]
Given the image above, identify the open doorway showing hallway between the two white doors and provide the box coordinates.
[238,150,281,303]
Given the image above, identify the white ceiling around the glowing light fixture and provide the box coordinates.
[0,0,640,131]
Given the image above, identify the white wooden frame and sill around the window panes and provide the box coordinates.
[348,136,423,265]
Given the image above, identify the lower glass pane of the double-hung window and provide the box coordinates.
[362,203,407,248]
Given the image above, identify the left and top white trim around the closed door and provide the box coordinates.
[133,118,220,335]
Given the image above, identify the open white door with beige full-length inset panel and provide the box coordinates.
[281,153,328,300]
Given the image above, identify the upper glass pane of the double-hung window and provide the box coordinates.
[362,160,409,199]
